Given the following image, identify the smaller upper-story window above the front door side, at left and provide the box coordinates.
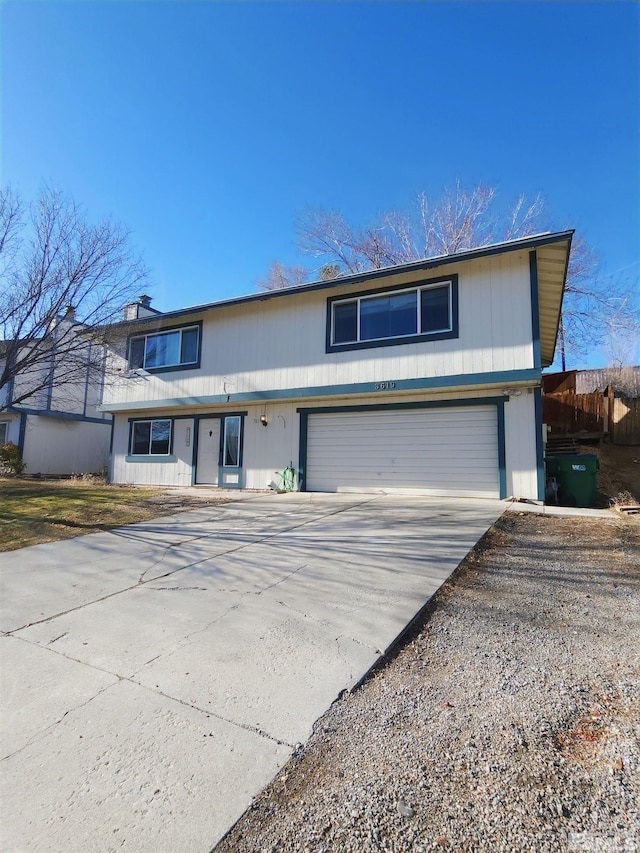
[129,323,202,371]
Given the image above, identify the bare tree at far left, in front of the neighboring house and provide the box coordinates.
[0,189,147,411]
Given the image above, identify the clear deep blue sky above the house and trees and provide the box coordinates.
[0,0,640,362]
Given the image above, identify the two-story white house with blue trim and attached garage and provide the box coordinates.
[101,231,573,500]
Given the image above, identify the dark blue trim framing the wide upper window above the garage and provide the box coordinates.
[325,273,459,353]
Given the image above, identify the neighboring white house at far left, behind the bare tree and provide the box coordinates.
[0,312,111,475]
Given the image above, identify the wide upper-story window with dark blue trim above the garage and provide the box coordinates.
[327,276,458,352]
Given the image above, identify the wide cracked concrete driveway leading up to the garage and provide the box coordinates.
[0,494,505,853]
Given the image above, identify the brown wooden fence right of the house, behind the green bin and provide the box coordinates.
[542,388,640,444]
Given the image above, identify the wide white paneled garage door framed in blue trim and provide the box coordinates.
[306,406,500,498]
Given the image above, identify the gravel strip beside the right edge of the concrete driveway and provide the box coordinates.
[216,513,640,853]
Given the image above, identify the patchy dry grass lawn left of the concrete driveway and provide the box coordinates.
[0,477,198,551]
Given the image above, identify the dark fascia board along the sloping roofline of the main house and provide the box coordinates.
[108,229,575,330]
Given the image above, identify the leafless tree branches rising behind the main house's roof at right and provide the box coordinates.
[255,181,638,370]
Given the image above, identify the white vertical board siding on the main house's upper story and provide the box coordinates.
[105,252,533,403]
